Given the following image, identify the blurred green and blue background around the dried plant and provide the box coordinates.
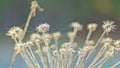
[0,0,120,68]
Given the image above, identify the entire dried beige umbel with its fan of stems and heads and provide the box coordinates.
[6,0,120,68]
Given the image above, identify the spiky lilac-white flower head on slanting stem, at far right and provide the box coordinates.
[102,20,116,33]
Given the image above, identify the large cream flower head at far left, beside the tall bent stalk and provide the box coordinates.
[6,26,23,39]
